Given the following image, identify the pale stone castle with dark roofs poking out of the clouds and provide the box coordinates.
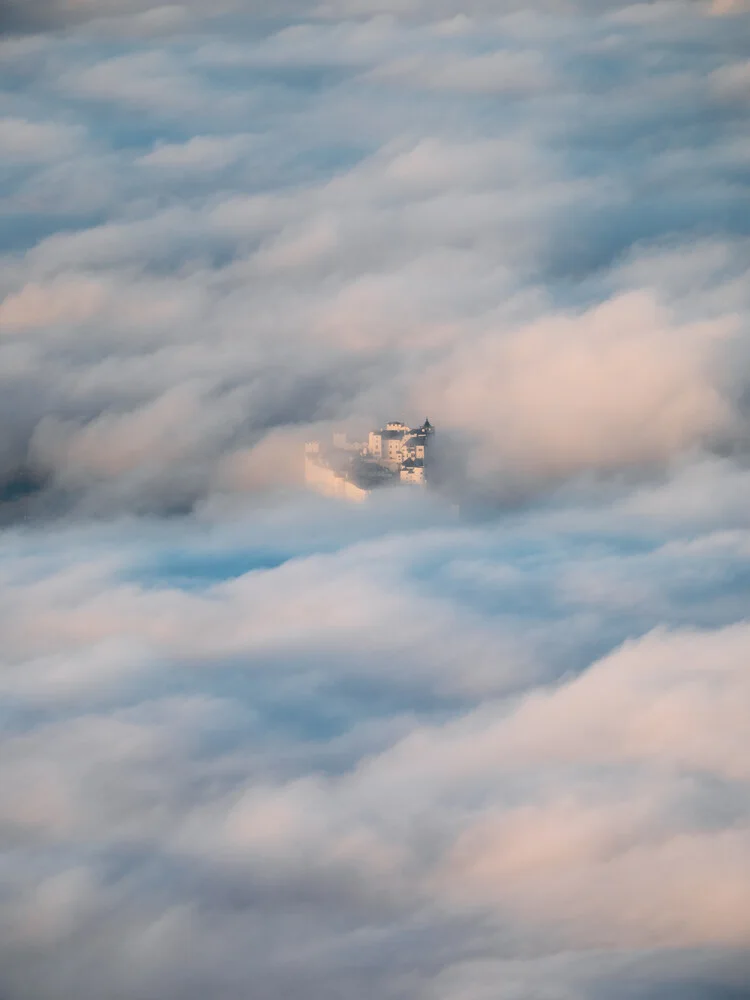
[305,420,435,500]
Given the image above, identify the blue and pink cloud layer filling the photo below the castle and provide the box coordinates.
[0,498,748,997]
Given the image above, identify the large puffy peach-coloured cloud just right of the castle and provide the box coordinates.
[423,293,732,490]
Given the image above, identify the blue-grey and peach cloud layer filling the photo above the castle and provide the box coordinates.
[0,3,748,512]
